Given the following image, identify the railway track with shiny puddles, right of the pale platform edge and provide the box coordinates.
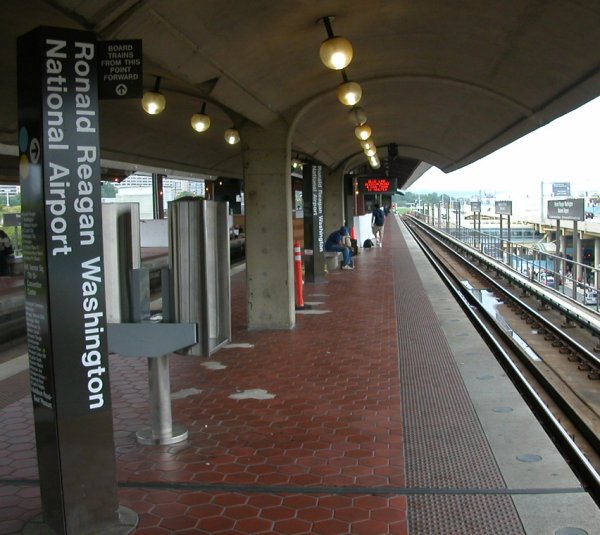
[403,217,600,506]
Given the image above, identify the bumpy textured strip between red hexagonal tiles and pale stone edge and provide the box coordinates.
[392,219,523,535]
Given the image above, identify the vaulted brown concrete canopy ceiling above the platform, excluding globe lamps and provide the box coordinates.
[0,0,600,187]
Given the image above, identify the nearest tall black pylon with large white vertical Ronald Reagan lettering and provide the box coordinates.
[17,27,130,535]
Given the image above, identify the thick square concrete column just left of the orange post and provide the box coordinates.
[240,124,296,330]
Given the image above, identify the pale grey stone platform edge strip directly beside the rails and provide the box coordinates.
[400,219,600,535]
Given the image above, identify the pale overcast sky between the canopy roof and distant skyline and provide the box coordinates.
[408,98,600,202]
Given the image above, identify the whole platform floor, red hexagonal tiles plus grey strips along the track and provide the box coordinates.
[0,216,600,535]
